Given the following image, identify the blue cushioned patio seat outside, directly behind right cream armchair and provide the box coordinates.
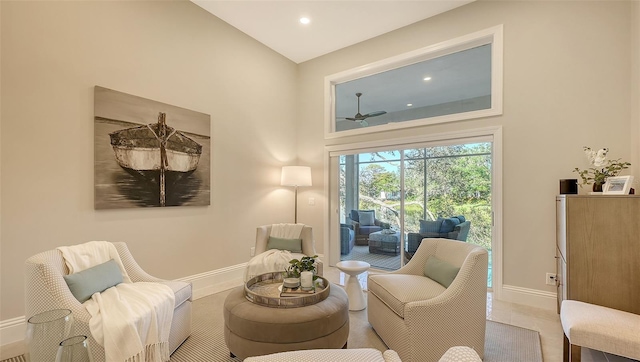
[407,215,471,254]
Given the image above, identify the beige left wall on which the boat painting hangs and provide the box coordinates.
[0,1,297,321]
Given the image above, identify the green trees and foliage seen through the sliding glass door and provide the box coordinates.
[352,143,491,250]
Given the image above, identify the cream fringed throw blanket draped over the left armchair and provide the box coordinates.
[58,241,175,362]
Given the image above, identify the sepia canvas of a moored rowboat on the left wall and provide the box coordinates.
[94,86,211,209]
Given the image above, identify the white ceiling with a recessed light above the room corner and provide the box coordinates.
[191,0,474,63]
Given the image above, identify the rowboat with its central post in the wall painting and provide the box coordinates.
[109,113,202,206]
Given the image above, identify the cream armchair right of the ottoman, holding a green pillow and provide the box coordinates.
[367,239,488,362]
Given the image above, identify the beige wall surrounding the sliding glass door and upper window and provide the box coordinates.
[298,1,640,296]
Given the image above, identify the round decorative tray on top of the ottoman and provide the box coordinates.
[244,272,329,308]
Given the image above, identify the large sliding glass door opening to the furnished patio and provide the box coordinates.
[336,140,493,287]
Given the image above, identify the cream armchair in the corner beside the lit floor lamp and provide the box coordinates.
[245,225,323,279]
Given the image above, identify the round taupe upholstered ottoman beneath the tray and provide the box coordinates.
[224,284,349,359]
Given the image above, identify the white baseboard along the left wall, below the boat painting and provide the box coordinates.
[0,263,247,350]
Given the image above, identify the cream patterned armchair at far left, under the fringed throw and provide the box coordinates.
[25,242,191,362]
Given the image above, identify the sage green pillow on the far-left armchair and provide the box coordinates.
[64,259,122,303]
